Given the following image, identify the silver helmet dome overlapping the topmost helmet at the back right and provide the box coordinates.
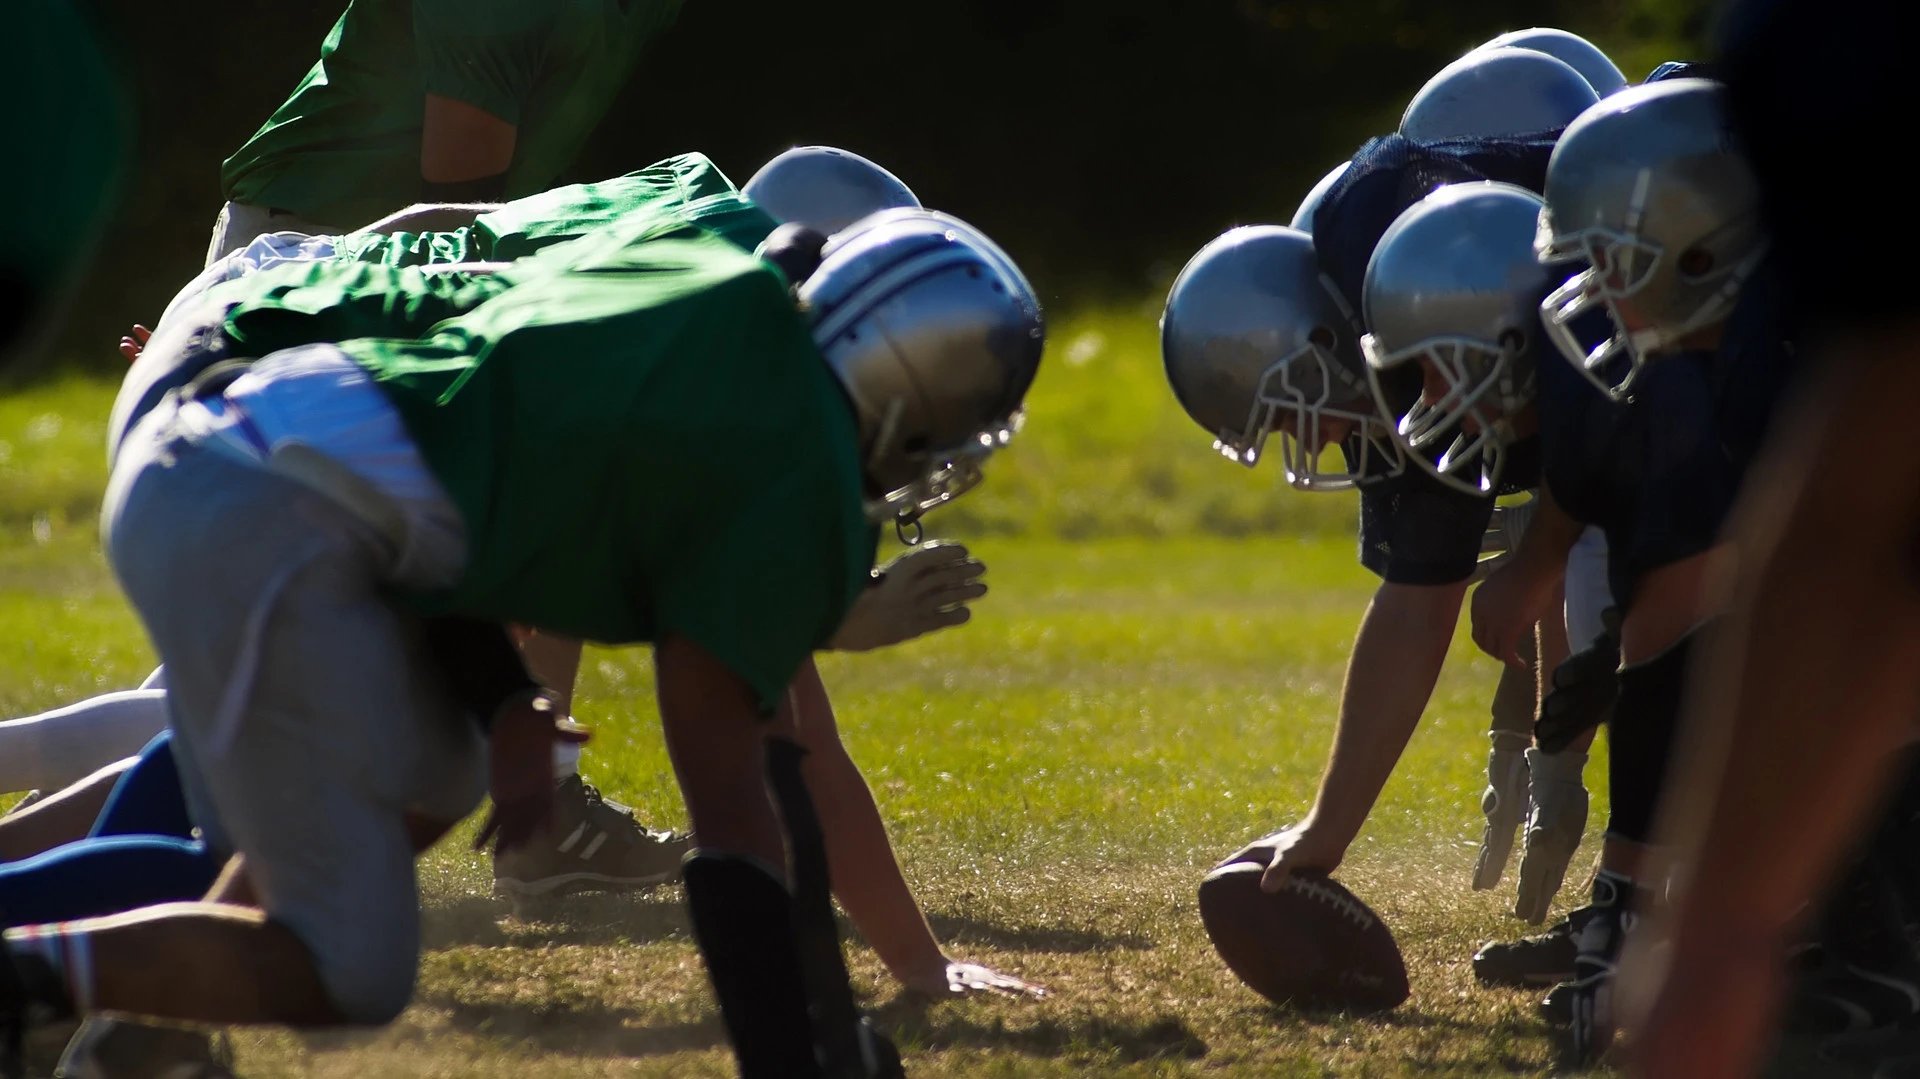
[1400,46,1599,142]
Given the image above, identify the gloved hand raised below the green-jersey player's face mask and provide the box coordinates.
[828,541,987,653]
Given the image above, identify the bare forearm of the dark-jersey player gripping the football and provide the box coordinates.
[1311,584,1467,843]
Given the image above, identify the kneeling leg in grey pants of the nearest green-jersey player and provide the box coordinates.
[0,426,460,1025]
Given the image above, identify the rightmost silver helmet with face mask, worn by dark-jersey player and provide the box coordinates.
[1534,79,1766,397]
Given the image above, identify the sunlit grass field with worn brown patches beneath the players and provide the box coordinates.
[0,311,1635,1079]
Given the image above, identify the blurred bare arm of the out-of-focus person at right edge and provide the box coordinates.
[1663,330,1920,933]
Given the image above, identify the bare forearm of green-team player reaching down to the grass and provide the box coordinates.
[791,662,947,985]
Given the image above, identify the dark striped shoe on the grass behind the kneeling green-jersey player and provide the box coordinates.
[493,776,693,900]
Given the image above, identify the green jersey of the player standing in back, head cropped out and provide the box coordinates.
[221,0,680,227]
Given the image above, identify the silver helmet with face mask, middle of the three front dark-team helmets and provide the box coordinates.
[1359,180,1551,493]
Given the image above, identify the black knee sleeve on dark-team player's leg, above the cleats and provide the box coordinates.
[1607,630,1699,843]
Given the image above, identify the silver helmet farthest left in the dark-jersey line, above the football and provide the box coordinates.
[1160,225,1404,492]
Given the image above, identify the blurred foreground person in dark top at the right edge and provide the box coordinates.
[1622,0,1920,1079]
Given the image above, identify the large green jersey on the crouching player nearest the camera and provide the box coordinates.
[342,225,877,710]
